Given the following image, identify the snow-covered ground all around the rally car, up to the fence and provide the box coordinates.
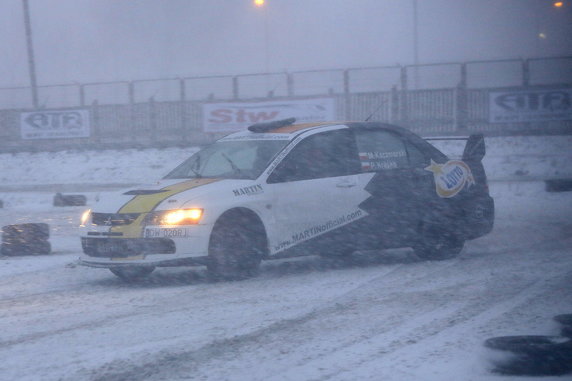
[0,137,572,381]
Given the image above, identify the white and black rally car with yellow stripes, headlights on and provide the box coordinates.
[80,119,494,279]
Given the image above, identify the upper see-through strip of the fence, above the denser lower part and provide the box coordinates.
[0,56,572,109]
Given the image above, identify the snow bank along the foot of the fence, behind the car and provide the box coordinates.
[0,136,572,187]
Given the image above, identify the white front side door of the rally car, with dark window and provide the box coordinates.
[267,128,368,253]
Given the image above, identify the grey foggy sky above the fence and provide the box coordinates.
[0,0,572,87]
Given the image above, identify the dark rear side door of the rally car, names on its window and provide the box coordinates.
[356,129,431,247]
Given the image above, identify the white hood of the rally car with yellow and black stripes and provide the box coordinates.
[93,178,225,213]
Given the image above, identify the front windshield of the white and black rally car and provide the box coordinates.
[165,140,288,179]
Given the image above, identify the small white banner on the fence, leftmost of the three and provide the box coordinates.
[20,109,90,139]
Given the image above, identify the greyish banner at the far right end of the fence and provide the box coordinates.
[489,89,572,123]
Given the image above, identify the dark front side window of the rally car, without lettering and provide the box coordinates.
[268,130,359,184]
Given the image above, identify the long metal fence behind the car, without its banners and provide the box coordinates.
[0,57,572,150]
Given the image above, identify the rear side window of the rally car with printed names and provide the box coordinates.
[356,130,409,172]
